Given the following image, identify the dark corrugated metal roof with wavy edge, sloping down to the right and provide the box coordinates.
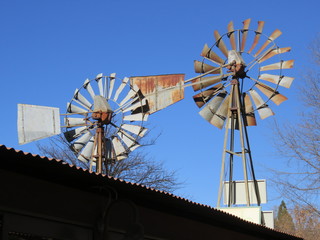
[0,145,302,239]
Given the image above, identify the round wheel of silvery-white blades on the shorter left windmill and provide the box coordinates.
[63,74,148,172]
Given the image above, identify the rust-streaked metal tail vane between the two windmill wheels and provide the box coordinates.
[130,74,184,114]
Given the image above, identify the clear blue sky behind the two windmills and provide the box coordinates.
[0,0,320,208]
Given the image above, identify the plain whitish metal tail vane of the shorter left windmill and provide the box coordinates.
[18,104,61,144]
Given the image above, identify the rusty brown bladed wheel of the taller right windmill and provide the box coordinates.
[193,19,294,128]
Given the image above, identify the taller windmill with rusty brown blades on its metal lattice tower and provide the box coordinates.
[193,19,294,210]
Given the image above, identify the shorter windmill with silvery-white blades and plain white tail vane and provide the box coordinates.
[18,73,148,174]
